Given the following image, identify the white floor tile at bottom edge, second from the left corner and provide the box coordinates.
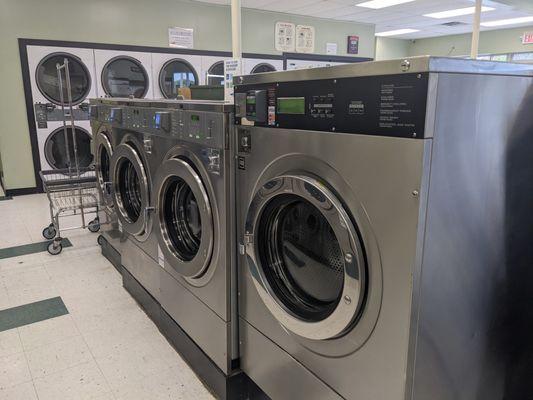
[34,361,111,400]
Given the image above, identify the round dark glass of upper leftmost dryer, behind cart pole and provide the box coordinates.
[35,53,91,105]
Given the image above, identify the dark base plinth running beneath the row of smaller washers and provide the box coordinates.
[122,268,268,400]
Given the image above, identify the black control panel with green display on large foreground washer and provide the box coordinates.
[235,73,429,138]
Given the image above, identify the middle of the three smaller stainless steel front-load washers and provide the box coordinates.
[102,99,161,300]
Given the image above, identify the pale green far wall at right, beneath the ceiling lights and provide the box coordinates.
[409,27,533,56]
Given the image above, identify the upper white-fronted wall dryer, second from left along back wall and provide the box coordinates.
[94,49,154,99]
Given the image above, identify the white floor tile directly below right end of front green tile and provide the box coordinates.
[18,315,80,351]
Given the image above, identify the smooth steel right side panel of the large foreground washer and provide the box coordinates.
[407,74,533,400]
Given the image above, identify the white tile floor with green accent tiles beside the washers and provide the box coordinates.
[0,195,214,400]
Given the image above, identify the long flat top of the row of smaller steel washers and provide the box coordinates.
[90,97,233,112]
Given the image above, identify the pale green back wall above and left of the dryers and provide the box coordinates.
[0,0,375,189]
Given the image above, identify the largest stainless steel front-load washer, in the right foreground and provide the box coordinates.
[235,57,533,400]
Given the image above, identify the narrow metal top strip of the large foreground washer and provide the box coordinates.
[233,56,533,86]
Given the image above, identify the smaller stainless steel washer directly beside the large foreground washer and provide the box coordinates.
[154,101,238,376]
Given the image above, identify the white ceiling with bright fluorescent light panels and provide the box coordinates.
[193,0,533,39]
